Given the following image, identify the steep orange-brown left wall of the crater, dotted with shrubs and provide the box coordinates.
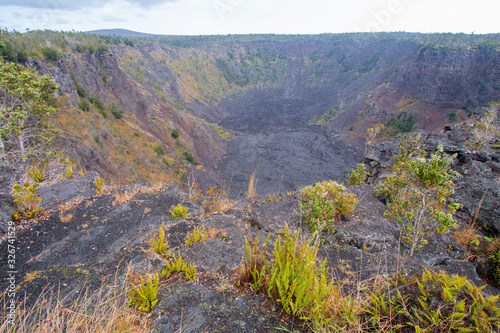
[24,53,218,183]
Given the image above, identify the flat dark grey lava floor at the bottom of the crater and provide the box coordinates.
[218,89,363,198]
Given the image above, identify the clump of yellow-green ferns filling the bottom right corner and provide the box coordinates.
[365,268,500,333]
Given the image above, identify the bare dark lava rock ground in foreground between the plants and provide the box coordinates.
[0,126,498,333]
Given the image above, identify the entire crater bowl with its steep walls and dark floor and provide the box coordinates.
[13,35,500,194]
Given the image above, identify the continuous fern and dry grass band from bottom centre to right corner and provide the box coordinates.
[237,227,500,333]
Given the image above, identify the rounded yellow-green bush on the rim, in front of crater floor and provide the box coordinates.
[299,181,359,231]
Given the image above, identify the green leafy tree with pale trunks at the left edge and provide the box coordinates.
[0,61,57,164]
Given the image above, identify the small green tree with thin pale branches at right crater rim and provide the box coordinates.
[377,135,462,255]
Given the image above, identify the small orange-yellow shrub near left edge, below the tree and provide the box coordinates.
[12,182,42,219]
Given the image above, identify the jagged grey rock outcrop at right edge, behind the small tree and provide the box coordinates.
[365,123,500,235]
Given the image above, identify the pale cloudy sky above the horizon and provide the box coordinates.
[0,0,500,35]
